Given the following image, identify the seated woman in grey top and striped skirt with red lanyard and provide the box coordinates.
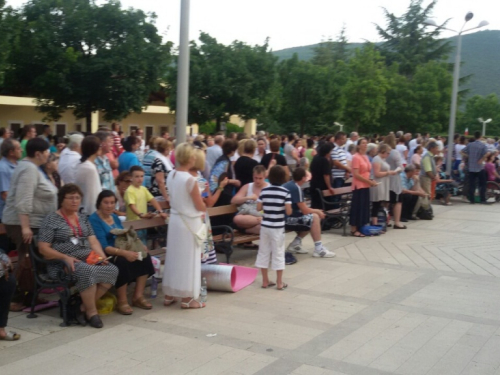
[38,184,118,328]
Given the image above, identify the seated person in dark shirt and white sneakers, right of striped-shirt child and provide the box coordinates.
[283,167,335,258]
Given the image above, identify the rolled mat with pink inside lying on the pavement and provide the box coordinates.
[201,263,259,293]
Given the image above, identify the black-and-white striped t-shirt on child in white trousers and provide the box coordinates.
[258,185,292,228]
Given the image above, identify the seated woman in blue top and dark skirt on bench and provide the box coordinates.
[89,190,155,315]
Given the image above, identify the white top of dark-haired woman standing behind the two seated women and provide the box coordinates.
[75,160,102,215]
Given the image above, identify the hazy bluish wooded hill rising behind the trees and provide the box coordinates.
[273,30,500,96]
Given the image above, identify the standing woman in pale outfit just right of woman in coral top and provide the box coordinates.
[370,144,396,229]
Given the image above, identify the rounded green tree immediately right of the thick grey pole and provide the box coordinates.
[169,32,278,130]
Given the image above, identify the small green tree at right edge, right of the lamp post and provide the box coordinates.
[457,94,500,135]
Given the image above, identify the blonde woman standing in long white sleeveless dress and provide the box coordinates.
[163,143,206,309]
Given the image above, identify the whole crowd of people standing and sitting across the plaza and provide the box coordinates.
[0,123,500,340]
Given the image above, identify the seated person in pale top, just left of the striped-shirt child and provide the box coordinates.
[231,165,269,235]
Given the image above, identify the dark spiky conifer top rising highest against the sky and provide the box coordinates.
[376,0,452,77]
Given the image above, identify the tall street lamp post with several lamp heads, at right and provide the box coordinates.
[424,12,488,176]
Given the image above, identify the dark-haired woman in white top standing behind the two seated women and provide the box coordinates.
[75,135,102,215]
